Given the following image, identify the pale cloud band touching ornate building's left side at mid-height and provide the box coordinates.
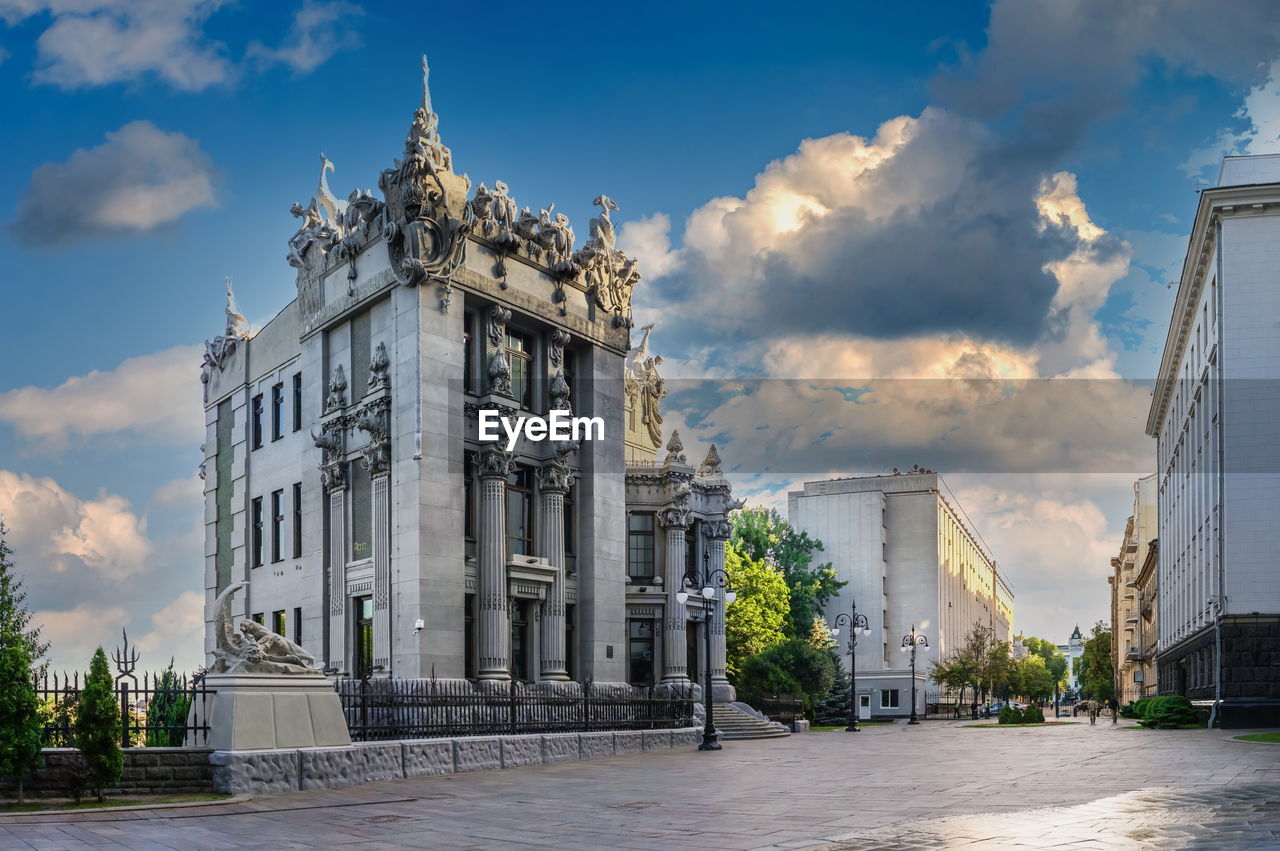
[0,346,204,448]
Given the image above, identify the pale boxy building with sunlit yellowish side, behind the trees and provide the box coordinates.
[787,468,1014,717]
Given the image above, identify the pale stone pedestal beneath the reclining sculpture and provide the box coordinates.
[205,673,351,750]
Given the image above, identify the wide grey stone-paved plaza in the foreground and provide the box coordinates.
[0,722,1280,848]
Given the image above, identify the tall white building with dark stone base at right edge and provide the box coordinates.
[1147,155,1280,727]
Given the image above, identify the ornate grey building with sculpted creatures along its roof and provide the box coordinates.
[201,60,737,699]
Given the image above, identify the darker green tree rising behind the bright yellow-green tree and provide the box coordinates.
[731,508,845,639]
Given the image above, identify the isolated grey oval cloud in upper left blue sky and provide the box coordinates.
[13,122,216,247]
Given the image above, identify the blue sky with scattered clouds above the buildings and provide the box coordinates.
[0,0,1280,665]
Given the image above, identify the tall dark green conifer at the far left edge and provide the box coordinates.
[0,522,49,804]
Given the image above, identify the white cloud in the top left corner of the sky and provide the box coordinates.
[0,0,234,91]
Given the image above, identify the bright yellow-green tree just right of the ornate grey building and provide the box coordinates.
[724,541,790,677]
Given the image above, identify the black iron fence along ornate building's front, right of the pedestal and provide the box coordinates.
[334,680,694,742]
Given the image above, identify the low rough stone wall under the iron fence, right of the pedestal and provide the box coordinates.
[209,727,703,795]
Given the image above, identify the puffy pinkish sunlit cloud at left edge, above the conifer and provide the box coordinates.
[0,470,155,580]
